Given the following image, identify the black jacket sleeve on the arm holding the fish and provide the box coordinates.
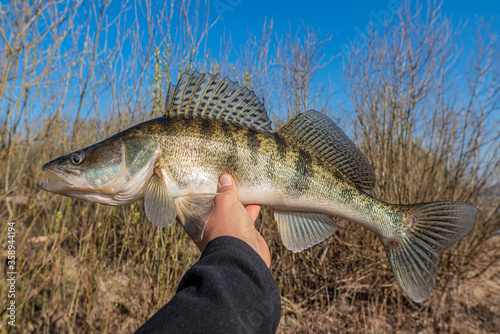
[136,237,281,333]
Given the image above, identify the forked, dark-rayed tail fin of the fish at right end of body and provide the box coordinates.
[382,201,477,303]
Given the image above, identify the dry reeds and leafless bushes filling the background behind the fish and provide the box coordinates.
[0,0,500,333]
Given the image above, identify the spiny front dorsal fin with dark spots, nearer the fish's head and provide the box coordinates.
[165,71,271,132]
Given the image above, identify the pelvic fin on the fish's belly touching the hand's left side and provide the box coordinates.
[175,194,216,241]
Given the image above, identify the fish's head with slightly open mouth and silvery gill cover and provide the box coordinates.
[42,136,156,205]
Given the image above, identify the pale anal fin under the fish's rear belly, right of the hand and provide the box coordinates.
[274,210,337,253]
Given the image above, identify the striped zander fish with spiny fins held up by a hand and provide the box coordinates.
[42,72,477,302]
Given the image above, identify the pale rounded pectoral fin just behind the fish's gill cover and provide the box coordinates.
[144,174,177,227]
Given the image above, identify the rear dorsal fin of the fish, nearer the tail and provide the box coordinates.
[278,110,375,189]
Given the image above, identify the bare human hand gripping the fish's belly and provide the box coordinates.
[195,174,271,267]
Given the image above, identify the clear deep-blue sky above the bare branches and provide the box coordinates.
[66,0,500,112]
